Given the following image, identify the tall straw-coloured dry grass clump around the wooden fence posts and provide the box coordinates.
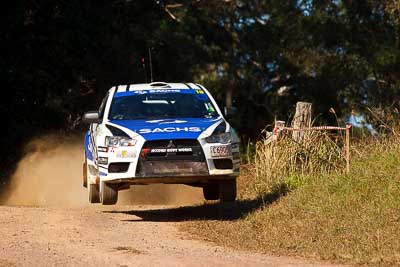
[254,131,345,195]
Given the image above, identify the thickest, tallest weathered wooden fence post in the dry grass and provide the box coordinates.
[292,102,312,142]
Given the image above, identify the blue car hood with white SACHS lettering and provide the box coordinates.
[110,117,223,140]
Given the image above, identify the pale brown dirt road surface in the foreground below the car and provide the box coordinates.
[0,206,340,266]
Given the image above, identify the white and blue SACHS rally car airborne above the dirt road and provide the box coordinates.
[83,82,240,205]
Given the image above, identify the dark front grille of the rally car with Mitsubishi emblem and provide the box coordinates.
[136,139,208,177]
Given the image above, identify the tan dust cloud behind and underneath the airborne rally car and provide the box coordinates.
[0,135,203,207]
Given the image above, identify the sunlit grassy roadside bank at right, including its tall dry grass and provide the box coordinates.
[184,133,400,266]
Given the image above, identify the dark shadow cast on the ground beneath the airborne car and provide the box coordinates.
[104,186,288,222]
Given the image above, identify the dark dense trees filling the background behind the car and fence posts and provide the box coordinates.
[0,0,400,178]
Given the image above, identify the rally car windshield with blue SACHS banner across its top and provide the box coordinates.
[108,89,218,120]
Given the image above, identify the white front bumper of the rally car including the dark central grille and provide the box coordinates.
[98,140,240,184]
